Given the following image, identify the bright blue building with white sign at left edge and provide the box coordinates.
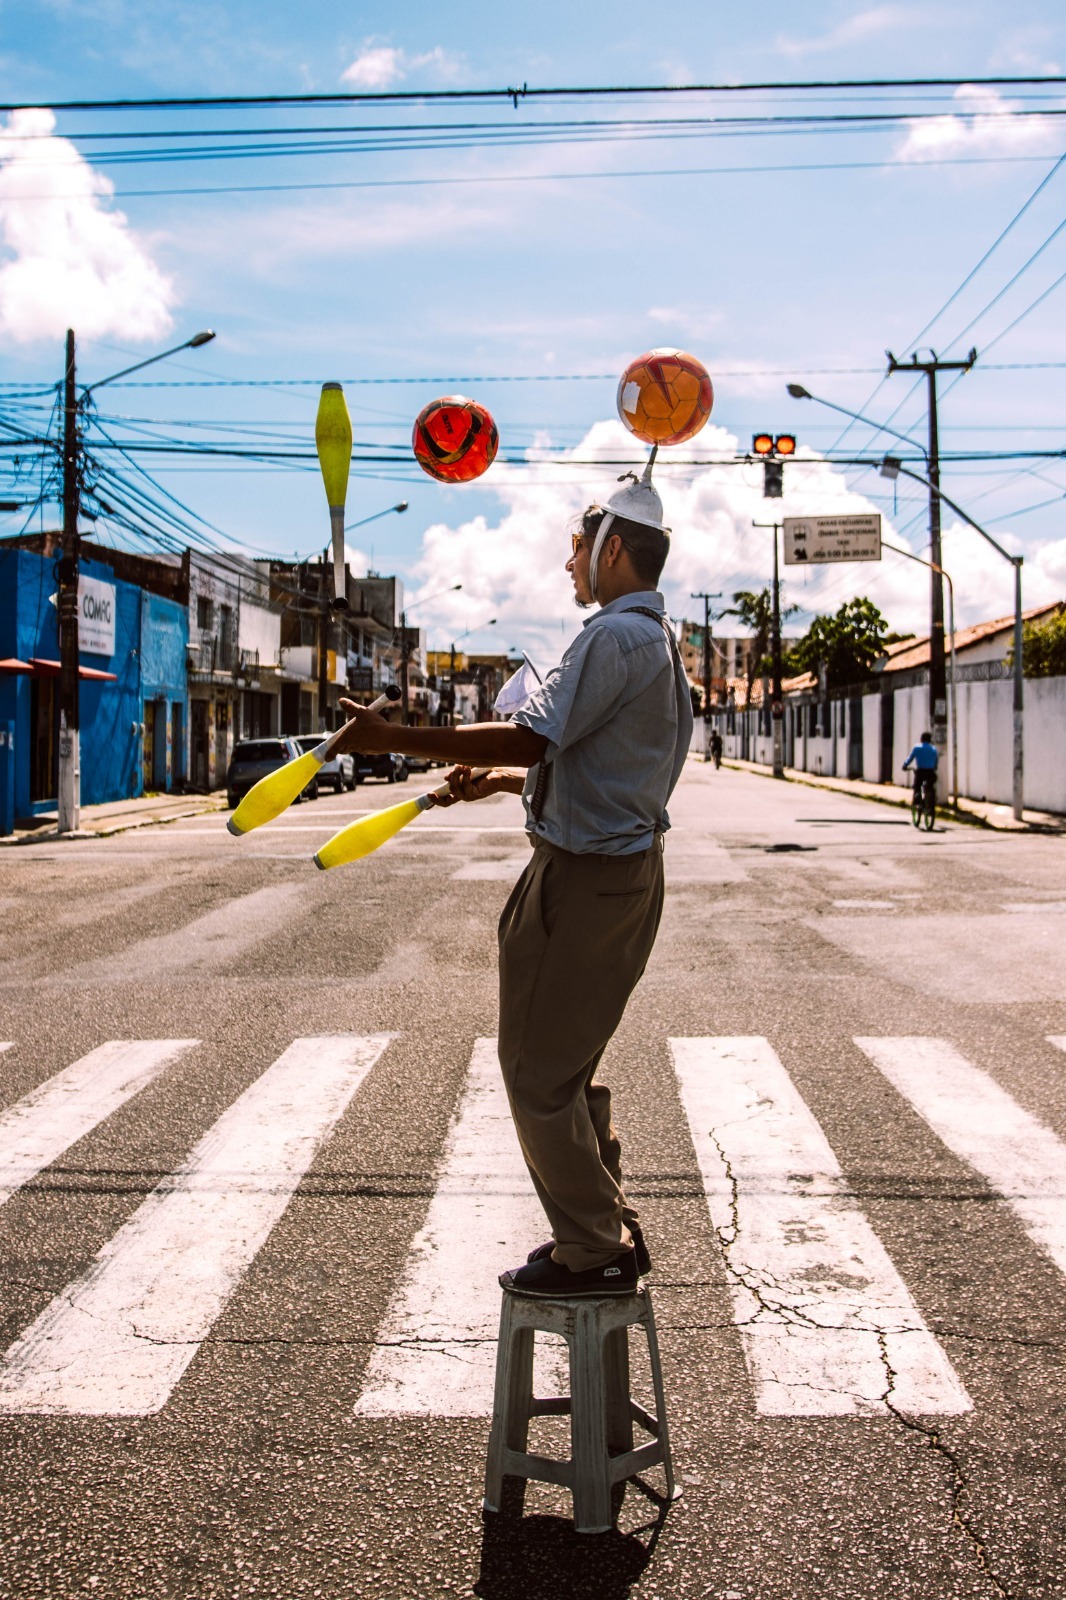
[0,534,189,818]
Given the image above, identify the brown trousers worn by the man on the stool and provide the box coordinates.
[499,838,663,1272]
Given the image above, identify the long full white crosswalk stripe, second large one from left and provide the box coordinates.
[0,1034,392,1416]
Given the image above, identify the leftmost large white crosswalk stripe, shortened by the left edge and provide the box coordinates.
[0,1038,198,1205]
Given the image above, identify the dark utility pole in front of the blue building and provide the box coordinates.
[56,328,82,834]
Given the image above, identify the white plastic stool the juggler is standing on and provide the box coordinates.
[485,1285,680,1533]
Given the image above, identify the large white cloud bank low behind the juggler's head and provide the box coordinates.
[400,421,1005,670]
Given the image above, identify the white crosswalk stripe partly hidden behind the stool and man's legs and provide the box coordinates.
[355,1038,565,1416]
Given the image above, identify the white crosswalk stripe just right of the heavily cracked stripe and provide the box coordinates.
[855,1038,1066,1272]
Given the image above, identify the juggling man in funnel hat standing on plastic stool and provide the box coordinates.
[339,462,691,1298]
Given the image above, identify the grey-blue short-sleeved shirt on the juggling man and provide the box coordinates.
[514,589,691,856]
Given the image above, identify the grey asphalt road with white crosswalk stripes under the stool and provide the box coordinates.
[0,763,1066,1600]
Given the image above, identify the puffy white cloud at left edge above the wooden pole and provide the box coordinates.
[0,110,174,344]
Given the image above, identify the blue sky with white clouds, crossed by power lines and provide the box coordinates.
[0,0,1066,658]
